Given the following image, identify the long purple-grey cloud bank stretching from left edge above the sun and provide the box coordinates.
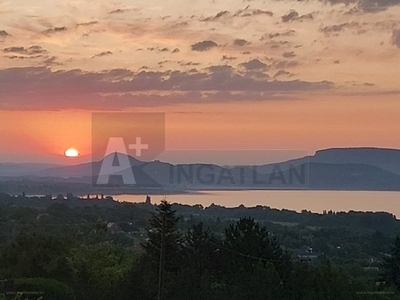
[0,65,334,110]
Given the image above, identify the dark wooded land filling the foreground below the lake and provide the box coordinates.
[0,197,400,300]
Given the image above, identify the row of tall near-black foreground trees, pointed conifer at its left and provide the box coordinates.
[118,202,400,300]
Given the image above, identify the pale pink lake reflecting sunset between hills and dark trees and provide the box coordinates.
[114,190,400,216]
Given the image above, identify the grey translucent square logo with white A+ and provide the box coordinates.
[92,113,165,187]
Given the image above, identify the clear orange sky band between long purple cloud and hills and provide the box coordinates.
[0,96,400,163]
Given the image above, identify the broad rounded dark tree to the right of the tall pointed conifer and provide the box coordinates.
[223,218,291,300]
